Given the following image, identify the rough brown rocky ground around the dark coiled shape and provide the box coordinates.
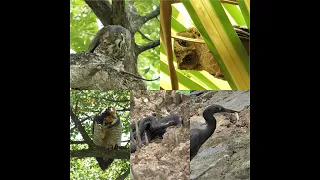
[130,91,190,180]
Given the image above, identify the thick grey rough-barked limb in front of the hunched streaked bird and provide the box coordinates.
[70,52,146,90]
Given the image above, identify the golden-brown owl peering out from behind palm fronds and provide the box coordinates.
[172,26,250,80]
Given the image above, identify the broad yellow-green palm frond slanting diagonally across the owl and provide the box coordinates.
[182,0,250,89]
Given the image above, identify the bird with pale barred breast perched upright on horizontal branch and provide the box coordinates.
[92,107,122,170]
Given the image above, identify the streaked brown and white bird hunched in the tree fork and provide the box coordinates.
[88,25,131,59]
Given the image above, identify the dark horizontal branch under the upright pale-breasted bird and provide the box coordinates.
[70,145,130,159]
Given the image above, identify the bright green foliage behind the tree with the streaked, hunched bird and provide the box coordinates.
[70,0,160,89]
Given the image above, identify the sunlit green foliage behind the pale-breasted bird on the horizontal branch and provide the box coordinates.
[70,90,130,180]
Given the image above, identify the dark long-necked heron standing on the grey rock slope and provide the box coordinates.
[190,104,237,161]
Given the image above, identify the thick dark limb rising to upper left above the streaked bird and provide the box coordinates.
[85,0,113,26]
